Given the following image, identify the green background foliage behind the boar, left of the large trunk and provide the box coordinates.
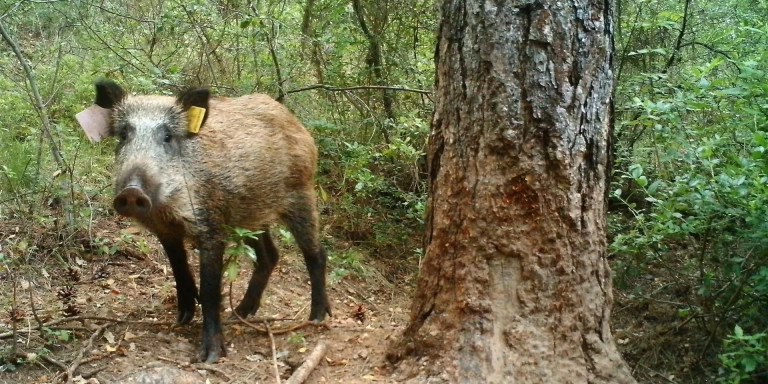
[0,0,437,260]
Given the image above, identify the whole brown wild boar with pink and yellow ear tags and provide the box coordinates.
[77,80,331,362]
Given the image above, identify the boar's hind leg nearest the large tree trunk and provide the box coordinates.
[283,190,331,321]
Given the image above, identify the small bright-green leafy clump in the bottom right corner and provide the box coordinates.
[719,325,768,384]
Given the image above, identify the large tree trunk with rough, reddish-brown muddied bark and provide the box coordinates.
[388,0,634,384]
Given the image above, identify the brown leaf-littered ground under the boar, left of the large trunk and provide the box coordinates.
[0,219,413,383]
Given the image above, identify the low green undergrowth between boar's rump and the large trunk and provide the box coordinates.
[309,117,428,255]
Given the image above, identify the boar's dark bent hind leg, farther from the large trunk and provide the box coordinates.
[235,229,280,317]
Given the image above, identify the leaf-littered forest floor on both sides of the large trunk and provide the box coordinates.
[0,218,716,384]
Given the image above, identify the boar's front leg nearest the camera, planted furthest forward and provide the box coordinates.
[199,238,227,363]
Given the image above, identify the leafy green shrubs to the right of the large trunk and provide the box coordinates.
[609,0,768,382]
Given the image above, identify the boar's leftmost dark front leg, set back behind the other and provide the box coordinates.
[160,237,197,325]
